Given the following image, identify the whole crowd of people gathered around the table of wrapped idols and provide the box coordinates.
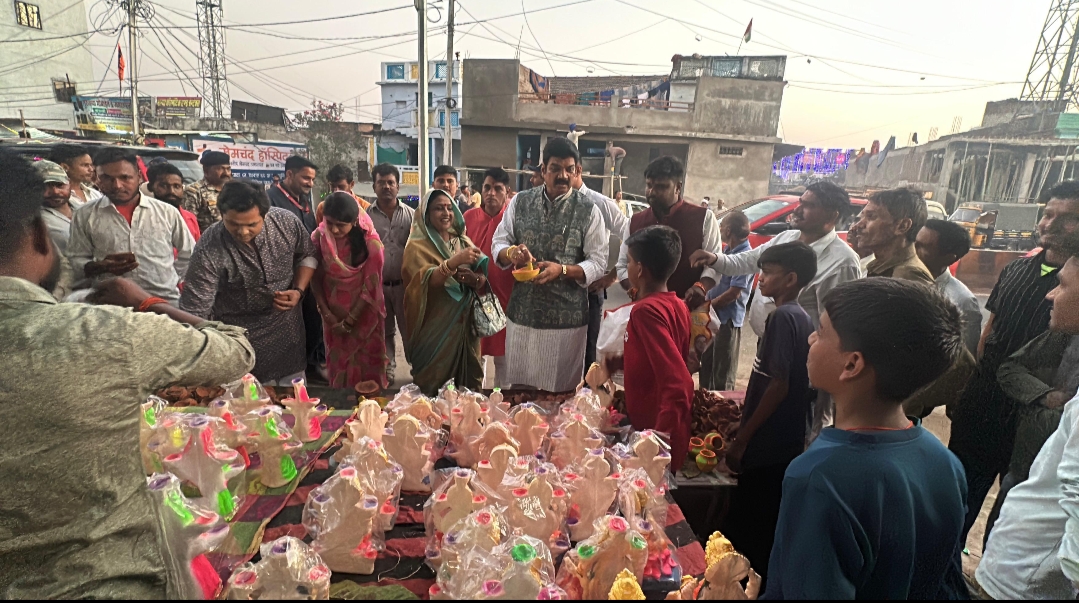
[6,138,1079,599]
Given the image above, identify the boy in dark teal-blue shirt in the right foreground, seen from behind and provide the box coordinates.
[765,278,968,599]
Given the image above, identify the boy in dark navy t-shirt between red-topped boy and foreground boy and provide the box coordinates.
[723,240,817,585]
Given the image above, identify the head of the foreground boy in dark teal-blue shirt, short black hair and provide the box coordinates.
[808,278,962,403]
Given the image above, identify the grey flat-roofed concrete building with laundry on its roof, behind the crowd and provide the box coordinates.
[462,55,787,207]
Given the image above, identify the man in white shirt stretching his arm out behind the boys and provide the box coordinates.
[691,181,862,440]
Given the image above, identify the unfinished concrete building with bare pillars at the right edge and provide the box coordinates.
[837,99,1079,213]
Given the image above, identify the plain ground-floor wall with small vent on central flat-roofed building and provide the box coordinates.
[683,140,773,207]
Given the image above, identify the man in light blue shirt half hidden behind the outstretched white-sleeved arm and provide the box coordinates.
[700,211,753,390]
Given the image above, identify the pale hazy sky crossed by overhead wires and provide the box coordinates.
[86,0,1052,149]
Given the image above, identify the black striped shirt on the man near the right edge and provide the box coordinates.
[983,251,1060,370]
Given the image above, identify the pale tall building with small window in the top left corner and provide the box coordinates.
[0,0,96,131]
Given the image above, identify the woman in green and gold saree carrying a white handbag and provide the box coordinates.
[401,190,488,396]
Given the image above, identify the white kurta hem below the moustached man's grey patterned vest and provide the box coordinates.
[495,320,588,392]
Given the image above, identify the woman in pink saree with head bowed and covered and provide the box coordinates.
[311,192,388,389]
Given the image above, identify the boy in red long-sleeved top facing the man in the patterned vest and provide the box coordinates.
[624,225,693,471]
